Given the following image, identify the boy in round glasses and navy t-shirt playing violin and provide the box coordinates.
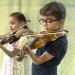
[22,1,68,75]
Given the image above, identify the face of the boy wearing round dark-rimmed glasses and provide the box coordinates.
[39,16,64,32]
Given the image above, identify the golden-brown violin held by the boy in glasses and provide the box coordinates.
[17,30,68,61]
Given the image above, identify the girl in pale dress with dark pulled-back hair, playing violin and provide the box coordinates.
[0,12,28,75]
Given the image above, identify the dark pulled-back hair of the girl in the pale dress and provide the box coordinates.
[9,12,26,22]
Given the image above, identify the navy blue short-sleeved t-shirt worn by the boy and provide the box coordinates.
[32,36,68,75]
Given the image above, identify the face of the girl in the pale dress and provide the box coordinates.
[9,16,20,31]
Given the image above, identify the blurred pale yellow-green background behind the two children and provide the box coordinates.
[0,0,75,75]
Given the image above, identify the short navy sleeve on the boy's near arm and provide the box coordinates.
[46,41,63,58]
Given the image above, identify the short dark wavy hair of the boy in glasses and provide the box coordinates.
[40,1,66,20]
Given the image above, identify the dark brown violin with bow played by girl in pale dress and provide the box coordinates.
[0,20,32,45]
